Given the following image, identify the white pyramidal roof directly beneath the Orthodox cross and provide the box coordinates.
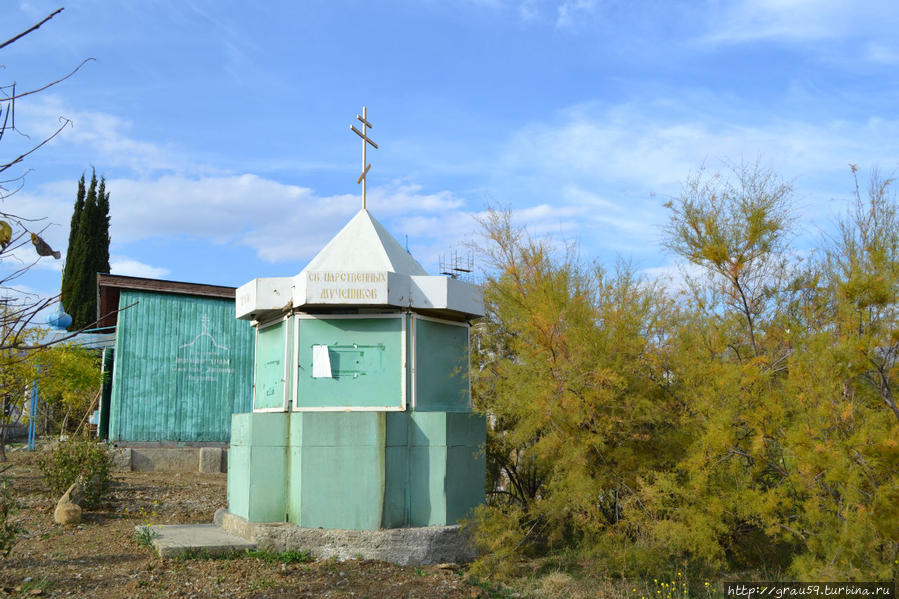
[301,208,428,275]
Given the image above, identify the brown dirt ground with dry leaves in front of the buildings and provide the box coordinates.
[0,450,506,599]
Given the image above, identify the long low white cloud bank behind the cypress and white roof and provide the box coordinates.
[8,174,478,268]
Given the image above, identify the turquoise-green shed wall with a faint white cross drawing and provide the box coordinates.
[109,290,253,441]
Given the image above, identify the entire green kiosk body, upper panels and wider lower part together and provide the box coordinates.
[228,304,486,530]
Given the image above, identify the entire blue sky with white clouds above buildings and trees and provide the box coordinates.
[0,0,899,304]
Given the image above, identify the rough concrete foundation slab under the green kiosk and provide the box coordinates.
[215,509,476,566]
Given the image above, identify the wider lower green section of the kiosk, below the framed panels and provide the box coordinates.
[228,412,486,530]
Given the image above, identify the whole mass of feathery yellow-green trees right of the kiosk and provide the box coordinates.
[472,164,899,580]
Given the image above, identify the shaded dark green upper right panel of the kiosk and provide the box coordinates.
[414,318,471,412]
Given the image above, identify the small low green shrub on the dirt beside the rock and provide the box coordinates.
[38,436,112,509]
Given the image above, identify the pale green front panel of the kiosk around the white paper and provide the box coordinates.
[297,317,405,408]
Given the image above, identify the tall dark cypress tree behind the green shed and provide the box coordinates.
[63,171,109,330]
